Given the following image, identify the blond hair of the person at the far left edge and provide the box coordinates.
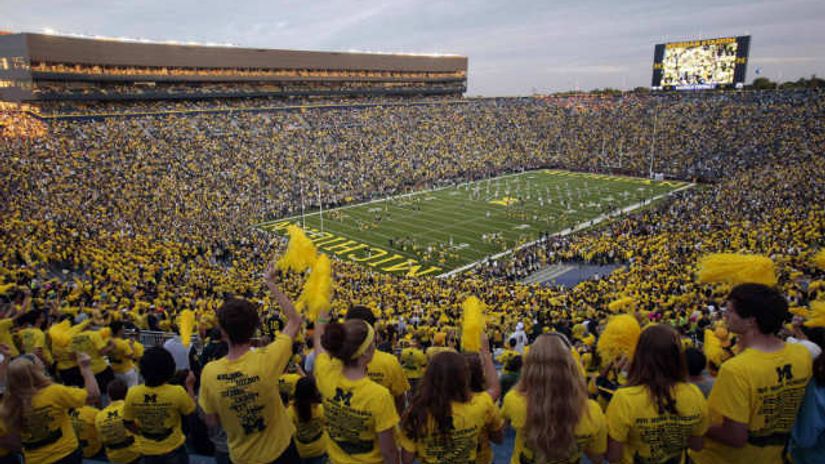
[0,355,52,430]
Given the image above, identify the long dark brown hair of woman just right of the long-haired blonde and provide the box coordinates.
[627,325,687,414]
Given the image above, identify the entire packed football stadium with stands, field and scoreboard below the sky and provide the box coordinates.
[0,18,825,464]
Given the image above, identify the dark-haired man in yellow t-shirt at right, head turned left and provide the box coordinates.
[691,284,811,464]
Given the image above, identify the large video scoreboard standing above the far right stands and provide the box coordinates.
[651,36,751,90]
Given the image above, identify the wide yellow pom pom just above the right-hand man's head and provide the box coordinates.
[699,253,777,286]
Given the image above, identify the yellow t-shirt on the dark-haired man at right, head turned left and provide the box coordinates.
[690,343,812,464]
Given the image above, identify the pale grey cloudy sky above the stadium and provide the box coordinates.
[0,0,825,96]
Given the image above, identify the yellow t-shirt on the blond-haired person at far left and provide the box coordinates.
[20,384,87,464]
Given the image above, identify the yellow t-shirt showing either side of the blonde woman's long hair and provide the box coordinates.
[501,389,607,464]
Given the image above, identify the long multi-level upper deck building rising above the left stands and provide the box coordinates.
[0,33,467,102]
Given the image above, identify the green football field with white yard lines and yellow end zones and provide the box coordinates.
[257,170,692,276]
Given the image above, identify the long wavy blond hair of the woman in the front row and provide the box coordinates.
[515,334,587,462]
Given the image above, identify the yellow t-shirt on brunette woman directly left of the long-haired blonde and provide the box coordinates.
[399,393,504,464]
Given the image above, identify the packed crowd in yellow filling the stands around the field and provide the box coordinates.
[0,91,825,462]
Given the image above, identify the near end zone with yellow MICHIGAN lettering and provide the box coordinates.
[257,221,443,277]
